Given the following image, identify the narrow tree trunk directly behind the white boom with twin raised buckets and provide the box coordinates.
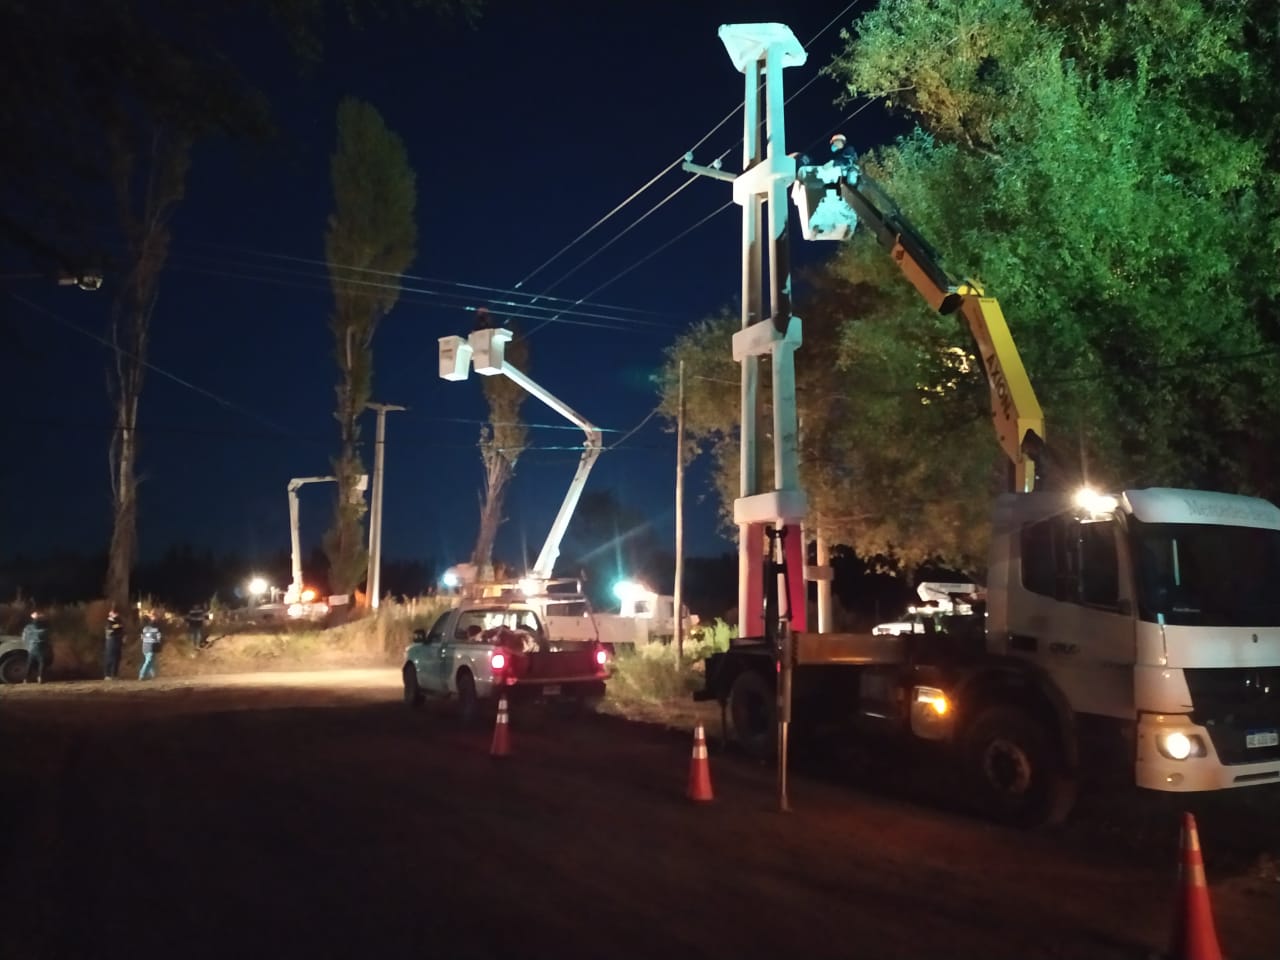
[471,307,529,580]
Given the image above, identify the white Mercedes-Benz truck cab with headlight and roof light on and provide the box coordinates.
[987,488,1280,791]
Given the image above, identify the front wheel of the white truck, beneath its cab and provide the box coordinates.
[961,705,1076,827]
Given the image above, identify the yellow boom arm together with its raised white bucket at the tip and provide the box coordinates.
[792,159,1044,493]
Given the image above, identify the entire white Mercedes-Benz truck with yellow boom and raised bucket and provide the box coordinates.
[686,20,1280,824]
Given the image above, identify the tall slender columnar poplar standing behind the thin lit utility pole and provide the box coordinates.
[325,97,417,594]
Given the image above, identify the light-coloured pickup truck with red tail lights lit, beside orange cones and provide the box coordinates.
[402,600,609,719]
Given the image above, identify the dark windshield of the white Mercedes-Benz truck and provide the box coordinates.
[1130,520,1280,627]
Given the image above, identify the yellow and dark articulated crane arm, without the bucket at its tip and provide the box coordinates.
[824,168,1044,493]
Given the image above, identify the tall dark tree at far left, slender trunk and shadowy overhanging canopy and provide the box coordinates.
[0,0,480,604]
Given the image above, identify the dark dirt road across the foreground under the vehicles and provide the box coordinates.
[0,671,1280,960]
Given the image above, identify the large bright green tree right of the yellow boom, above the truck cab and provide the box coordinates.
[836,0,1276,512]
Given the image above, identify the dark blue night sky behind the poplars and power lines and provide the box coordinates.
[0,0,883,586]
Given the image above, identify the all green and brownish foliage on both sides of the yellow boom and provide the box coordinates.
[667,0,1280,570]
